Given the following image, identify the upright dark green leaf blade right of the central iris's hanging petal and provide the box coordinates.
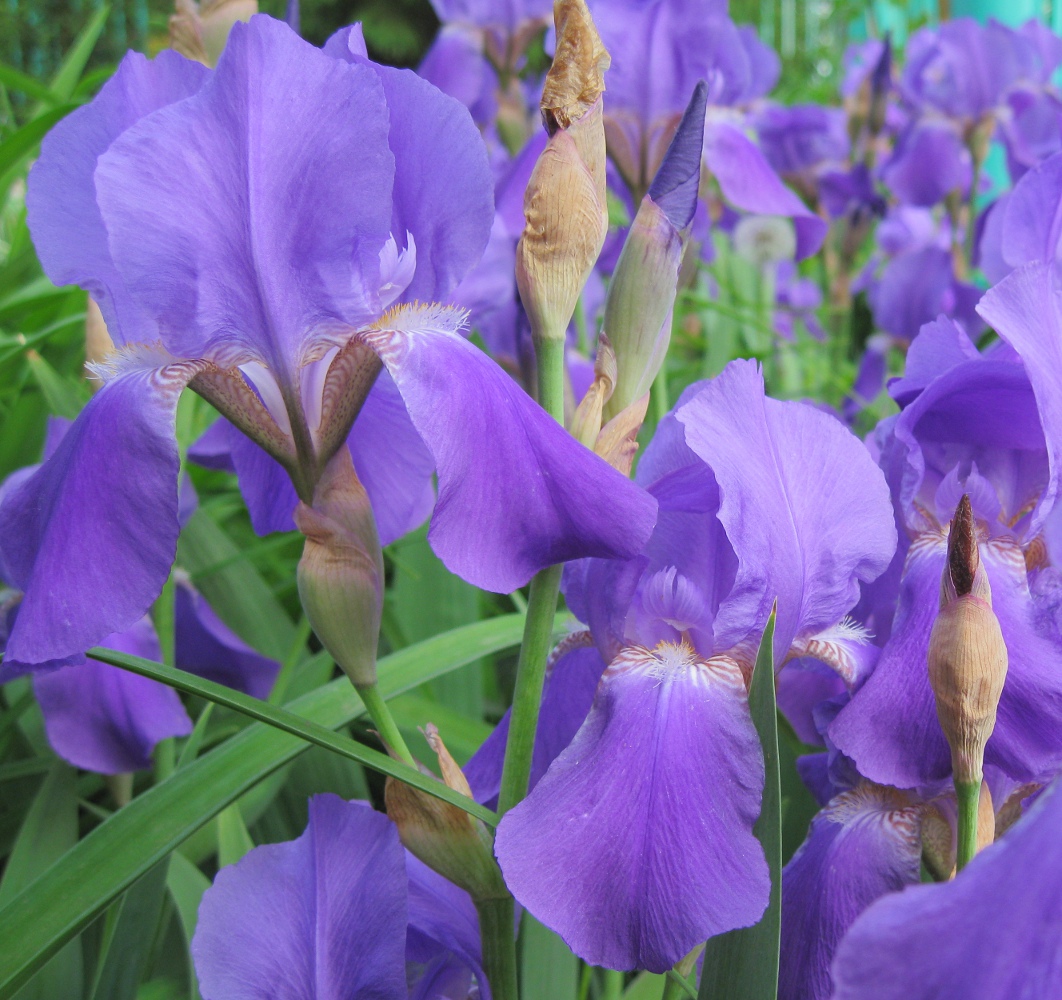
[699,614,782,1000]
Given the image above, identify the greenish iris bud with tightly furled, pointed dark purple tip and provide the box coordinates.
[604,81,707,419]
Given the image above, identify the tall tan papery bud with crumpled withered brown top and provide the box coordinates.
[516,0,610,341]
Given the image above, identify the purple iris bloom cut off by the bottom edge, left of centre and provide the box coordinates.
[192,795,491,1000]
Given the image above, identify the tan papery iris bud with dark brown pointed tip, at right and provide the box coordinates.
[929,496,1007,786]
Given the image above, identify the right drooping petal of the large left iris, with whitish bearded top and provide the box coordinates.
[358,308,656,592]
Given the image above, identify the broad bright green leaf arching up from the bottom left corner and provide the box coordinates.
[0,615,535,1000]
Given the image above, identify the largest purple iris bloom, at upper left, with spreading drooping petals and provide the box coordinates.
[0,16,654,677]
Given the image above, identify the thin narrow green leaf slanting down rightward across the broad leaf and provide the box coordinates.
[89,649,498,826]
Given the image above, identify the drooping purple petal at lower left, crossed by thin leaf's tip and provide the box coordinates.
[33,618,192,774]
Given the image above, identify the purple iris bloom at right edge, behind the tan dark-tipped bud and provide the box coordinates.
[829,314,1062,788]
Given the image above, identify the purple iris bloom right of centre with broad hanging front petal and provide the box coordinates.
[488,361,894,971]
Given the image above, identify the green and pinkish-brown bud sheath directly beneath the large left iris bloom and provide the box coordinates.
[295,448,383,689]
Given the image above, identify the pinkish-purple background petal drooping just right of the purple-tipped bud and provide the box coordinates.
[704,120,826,260]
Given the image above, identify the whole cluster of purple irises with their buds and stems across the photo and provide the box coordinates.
[0,0,1062,1000]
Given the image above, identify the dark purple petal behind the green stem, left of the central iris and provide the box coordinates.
[464,633,604,809]
